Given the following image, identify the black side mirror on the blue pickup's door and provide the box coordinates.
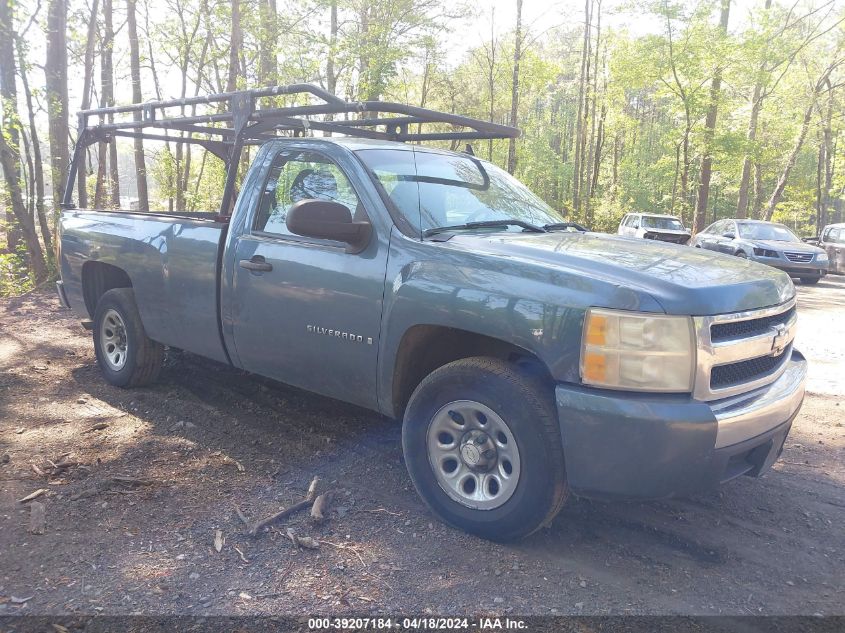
[285,199,373,253]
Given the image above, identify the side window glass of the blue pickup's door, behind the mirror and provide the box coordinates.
[253,150,363,235]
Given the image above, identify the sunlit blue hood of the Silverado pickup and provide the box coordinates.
[448,232,795,316]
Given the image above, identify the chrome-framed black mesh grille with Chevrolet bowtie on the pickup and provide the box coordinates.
[693,299,798,401]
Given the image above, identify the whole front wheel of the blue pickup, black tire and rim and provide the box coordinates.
[402,357,569,541]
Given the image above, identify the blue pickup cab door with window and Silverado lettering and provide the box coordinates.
[232,145,387,408]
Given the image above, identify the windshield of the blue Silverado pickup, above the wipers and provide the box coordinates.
[358,149,562,232]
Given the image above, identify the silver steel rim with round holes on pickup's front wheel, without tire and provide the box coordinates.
[426,400,521,510]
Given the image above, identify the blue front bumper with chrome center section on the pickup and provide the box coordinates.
[555,351,807,498]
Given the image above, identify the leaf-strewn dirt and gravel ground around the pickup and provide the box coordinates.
[0,277,845,615]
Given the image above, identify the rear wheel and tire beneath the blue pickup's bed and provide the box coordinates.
[92,288,164,387]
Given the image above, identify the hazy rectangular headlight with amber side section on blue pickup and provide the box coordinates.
[581,308,695,392]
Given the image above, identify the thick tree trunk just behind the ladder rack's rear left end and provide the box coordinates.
[44,0,70,214]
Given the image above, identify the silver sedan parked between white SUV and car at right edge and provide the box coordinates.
[690,220,828,284]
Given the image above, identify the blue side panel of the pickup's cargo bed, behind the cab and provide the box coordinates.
[60,209,228,362]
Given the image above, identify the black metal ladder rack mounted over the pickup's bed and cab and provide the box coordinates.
[62,84,519,216]
